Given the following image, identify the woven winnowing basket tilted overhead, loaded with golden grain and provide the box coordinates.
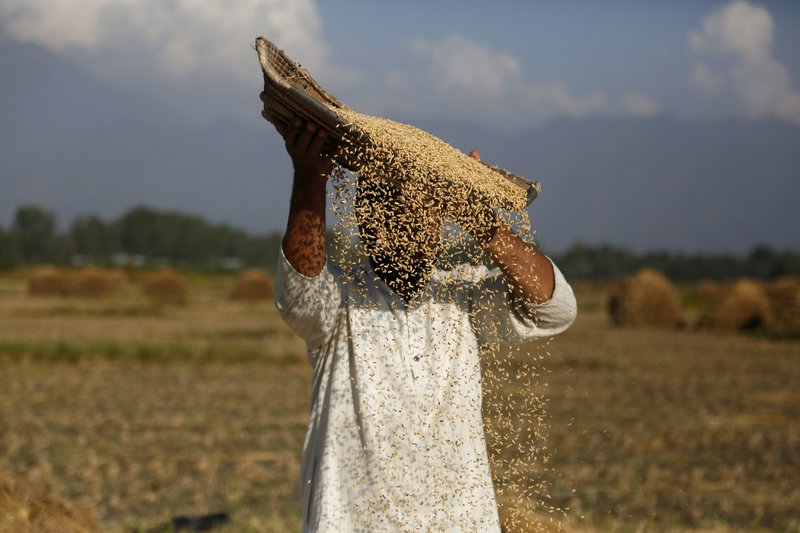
[256,37,540,214]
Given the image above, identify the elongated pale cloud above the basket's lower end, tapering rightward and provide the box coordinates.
[394,35,661,128]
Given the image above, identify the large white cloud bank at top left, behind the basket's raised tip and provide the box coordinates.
[0,0,331,81]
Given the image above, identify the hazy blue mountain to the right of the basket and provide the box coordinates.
[418,117,800,252]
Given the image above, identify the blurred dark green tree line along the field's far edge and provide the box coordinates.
[0,205,800,281]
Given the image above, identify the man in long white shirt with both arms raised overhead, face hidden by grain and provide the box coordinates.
[275,119,576,532]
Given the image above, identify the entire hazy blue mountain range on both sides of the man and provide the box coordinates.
[0,42,800,252]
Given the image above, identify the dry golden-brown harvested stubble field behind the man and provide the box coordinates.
[0,278,800,532]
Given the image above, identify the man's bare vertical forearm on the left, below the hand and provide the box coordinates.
[283,172,326,278]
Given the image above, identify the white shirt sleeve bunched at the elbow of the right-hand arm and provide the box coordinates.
[470,261,577,344]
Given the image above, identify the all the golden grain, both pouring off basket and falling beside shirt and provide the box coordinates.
[324,115,552,531]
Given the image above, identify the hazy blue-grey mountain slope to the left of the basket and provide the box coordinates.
[0,38,291,231]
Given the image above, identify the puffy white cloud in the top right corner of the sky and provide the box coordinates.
[689,0,800,123]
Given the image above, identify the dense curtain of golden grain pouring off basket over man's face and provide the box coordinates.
[324,107,532,300]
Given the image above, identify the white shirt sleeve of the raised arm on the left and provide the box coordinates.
[275,248,342,349]
